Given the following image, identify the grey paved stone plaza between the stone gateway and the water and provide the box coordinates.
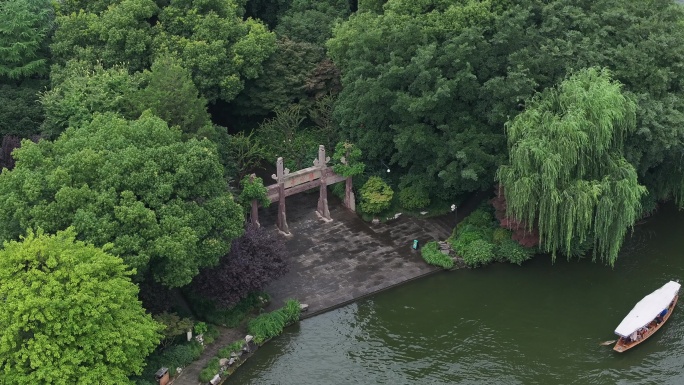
[260,193,455,317]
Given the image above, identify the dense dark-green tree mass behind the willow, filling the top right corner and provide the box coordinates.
[328,0,684,206]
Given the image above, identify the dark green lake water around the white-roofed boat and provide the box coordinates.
[227,206,684,385]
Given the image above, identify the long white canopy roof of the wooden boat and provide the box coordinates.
[615,281,681,337]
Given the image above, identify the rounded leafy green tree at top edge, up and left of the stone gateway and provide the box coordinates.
[155,0,276,102]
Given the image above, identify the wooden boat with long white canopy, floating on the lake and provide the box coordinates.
[613,281,681,353]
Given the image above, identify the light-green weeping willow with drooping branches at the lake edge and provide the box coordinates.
[497,68,646,266]
